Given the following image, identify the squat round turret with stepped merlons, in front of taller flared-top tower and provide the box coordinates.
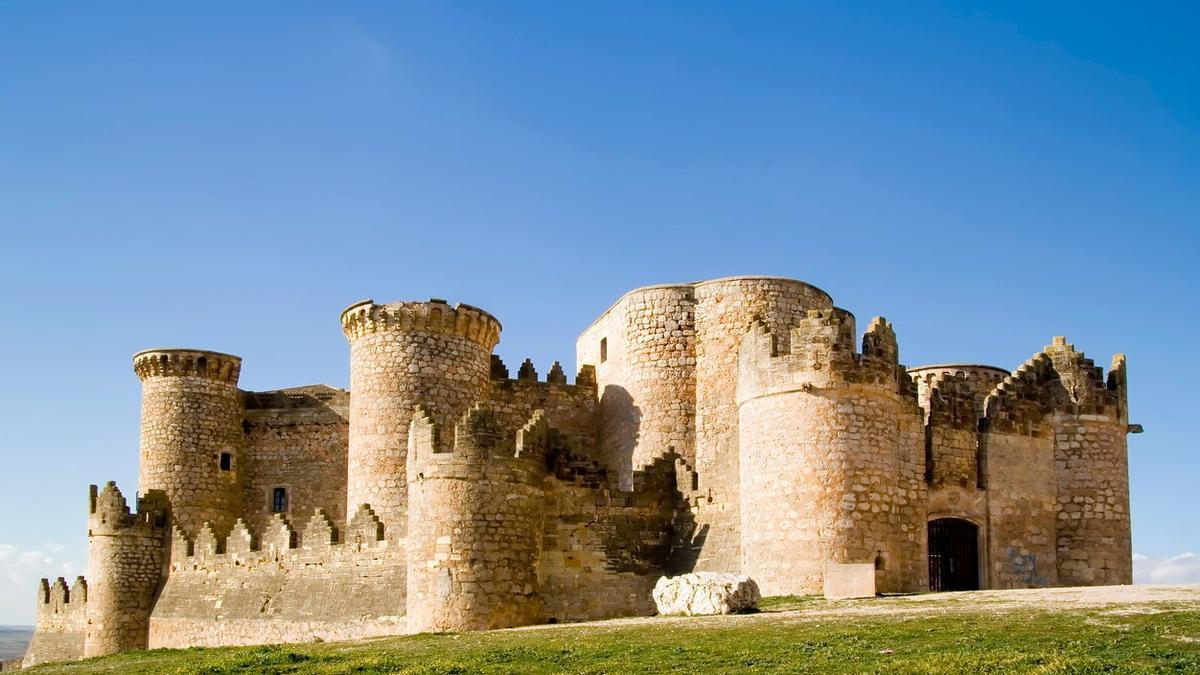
[406,407,550,632]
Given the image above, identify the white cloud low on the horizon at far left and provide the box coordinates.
[0,544,84,625]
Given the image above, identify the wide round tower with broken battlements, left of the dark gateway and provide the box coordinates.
[737,309,928,595]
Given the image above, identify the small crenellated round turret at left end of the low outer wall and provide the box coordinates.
[84,482,170,657]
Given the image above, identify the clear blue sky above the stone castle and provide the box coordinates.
[0,0,1200,623]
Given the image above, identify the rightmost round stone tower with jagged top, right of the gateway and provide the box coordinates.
[1044,338,1133,586]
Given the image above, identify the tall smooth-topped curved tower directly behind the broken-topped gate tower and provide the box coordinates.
[682,276,833,572]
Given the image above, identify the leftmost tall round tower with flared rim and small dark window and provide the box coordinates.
[133,350,245,537]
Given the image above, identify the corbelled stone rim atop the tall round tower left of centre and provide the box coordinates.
[342,298,500,350]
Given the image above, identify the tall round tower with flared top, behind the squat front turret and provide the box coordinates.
[342,300,500,540]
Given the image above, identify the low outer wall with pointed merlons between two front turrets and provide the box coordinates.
[149,507,406,649]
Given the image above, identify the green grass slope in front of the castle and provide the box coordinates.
[31,597,1200,675]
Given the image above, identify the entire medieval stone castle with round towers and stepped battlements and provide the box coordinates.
[25,276,1136,664]
